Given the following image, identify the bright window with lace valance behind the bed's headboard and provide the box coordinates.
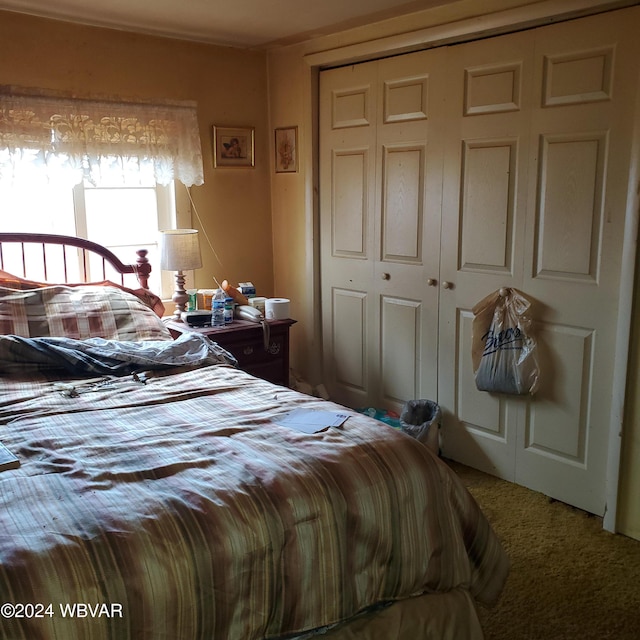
[0,85,204,297]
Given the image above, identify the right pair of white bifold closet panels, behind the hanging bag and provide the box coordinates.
[439,9,639,515]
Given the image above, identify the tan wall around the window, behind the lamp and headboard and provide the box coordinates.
[0,11,274,296]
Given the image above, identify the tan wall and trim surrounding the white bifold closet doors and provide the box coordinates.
[268,0,640,538]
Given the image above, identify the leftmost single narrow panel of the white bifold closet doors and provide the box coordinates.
[320,63,378,406]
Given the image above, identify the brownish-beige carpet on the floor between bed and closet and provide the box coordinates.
[449,462,640,640]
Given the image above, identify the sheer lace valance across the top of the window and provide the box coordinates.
[0,90,204,186]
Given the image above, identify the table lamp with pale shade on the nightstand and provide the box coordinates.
[160,229,202,321]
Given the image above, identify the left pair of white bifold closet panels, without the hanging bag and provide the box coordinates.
[320,51,445,410]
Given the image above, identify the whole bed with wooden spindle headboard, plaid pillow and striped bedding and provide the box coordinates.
[0,234,508,640]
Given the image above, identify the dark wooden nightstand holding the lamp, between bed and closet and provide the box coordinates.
[166,319,296,387]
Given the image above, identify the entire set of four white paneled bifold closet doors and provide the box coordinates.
[320,7,640,515]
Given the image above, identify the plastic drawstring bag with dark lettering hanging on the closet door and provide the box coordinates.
[472,289,540,395]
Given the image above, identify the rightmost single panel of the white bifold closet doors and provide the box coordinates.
[516,7,640,515]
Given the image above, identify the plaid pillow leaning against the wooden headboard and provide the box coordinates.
[0,284,171,342]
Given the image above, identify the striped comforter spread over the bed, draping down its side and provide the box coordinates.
[0,358,507,640]
